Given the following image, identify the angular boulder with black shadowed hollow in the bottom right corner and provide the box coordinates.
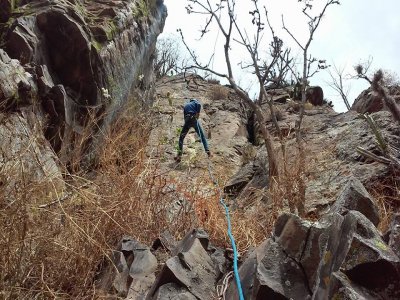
[313,211,400,300]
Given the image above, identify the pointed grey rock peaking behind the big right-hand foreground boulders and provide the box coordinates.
[330,177,380,226]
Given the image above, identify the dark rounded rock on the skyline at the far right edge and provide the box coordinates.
[351,86,400,114]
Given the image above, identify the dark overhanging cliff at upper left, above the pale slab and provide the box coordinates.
[0,0,166,159]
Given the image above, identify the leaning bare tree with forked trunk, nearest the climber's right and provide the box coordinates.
[180,0,291,178]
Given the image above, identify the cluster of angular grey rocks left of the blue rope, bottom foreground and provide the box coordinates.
[97,229,227,300]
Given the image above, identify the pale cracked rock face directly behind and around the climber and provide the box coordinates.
[148,74,255,188]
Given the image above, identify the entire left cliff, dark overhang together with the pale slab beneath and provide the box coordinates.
[0,0,167,199]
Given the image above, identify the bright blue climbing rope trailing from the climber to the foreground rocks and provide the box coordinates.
[196,120,244,300]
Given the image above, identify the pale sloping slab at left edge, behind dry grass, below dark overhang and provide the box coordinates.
[0,108,65,200]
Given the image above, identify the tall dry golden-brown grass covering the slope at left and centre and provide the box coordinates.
[0,102,276,299]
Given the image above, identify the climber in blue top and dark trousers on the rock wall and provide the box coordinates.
[175,99,211,162]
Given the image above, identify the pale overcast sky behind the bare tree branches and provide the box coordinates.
[161,0,400,112]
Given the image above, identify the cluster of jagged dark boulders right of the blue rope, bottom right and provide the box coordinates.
[226,182,400,299]
